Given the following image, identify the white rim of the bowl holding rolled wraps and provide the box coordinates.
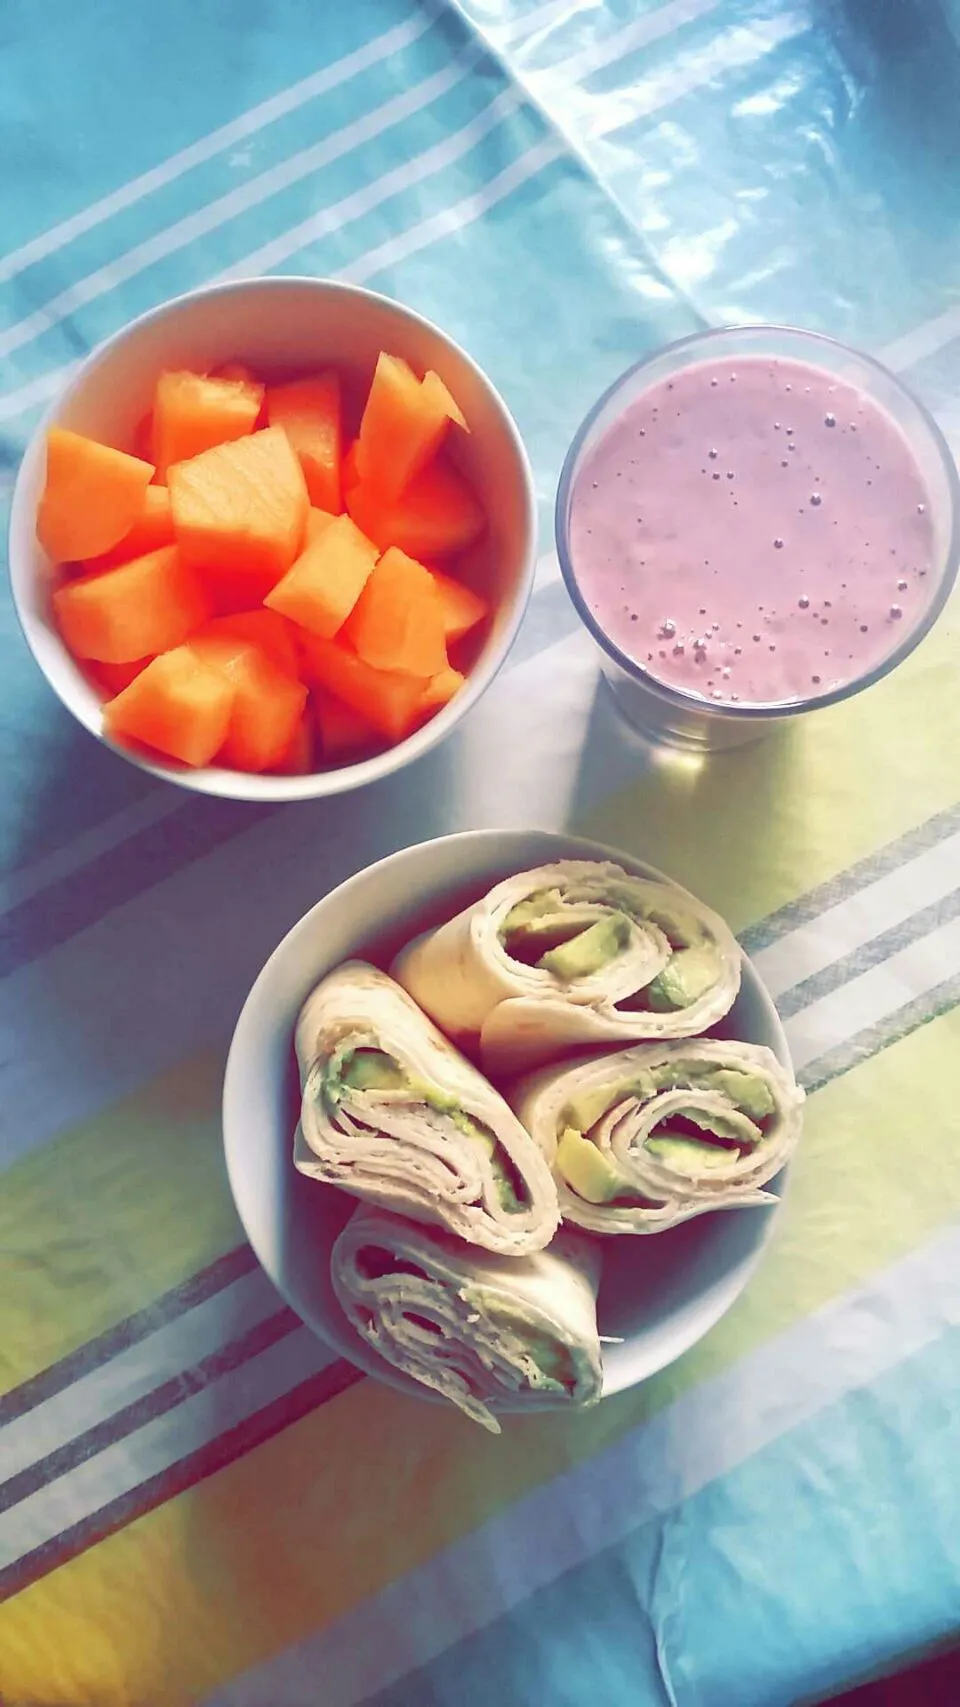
[220,828,794,1415]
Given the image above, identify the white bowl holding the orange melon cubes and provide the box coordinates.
[9,278,536,801]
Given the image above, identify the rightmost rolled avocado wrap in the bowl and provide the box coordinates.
[511,1038,803,1232]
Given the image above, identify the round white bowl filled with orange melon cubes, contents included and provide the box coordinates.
[10,278,536,801]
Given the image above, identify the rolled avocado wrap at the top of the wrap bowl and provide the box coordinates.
[391,860,740,1074]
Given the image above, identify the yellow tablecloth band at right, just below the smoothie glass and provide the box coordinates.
[577,597,960,930]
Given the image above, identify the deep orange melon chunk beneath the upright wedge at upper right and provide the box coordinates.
[345,456,485,562]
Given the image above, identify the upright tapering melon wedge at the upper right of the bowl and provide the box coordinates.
[355,352,466,498]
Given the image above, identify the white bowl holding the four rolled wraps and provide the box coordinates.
[224,830,789,1408]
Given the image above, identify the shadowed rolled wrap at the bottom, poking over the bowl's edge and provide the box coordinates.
[330,1207,601,1434]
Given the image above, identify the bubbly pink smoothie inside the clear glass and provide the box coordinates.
[571,357,934,703]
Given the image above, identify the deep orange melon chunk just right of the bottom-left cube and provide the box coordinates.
[188,630,307,772]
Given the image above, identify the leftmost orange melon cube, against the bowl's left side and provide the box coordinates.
[36,427,154,563]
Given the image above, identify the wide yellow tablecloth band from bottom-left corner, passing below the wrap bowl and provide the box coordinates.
[0,1011,960,1707]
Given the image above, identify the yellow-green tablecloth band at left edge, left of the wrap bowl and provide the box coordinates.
[0,1053,243,1391]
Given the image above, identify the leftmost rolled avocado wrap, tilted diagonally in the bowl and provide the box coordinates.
[294,961,560,1256]
